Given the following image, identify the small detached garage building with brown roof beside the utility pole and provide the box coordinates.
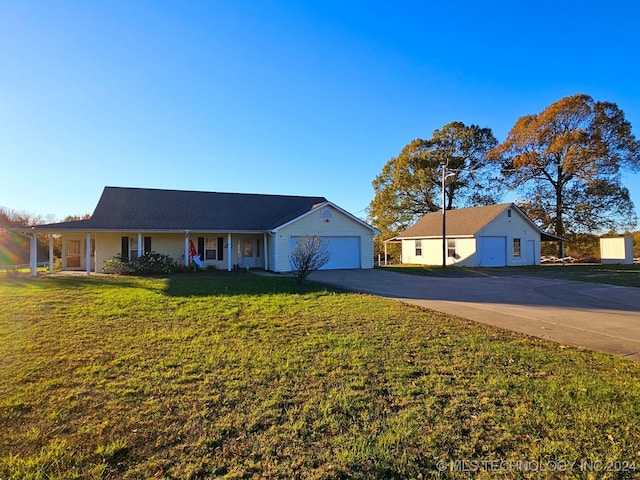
[386,203,564,267]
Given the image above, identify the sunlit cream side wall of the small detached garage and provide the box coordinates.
[402,237,476,267]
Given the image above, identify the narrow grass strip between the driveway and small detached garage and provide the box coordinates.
[379,264,640,287]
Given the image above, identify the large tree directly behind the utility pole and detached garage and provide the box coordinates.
[369,122,498,237]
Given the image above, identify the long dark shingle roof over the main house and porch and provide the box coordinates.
[35,187,327,231]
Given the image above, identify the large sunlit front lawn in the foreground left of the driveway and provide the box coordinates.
[0,272,640,480]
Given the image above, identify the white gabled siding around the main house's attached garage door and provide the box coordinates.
[270,206,373,272]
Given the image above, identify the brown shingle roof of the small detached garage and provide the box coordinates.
[395,203,564,241]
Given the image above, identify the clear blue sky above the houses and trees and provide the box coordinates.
[0,0,640,219]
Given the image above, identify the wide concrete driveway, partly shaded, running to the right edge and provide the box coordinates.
[309,269,640,361]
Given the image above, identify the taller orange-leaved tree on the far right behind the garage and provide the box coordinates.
[488,94,640,236]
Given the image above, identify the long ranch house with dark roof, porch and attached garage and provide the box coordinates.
[31,187,379,273]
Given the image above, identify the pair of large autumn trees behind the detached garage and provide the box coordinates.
[368,94,640,258]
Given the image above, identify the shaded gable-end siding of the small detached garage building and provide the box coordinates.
[476,209,540,266]
